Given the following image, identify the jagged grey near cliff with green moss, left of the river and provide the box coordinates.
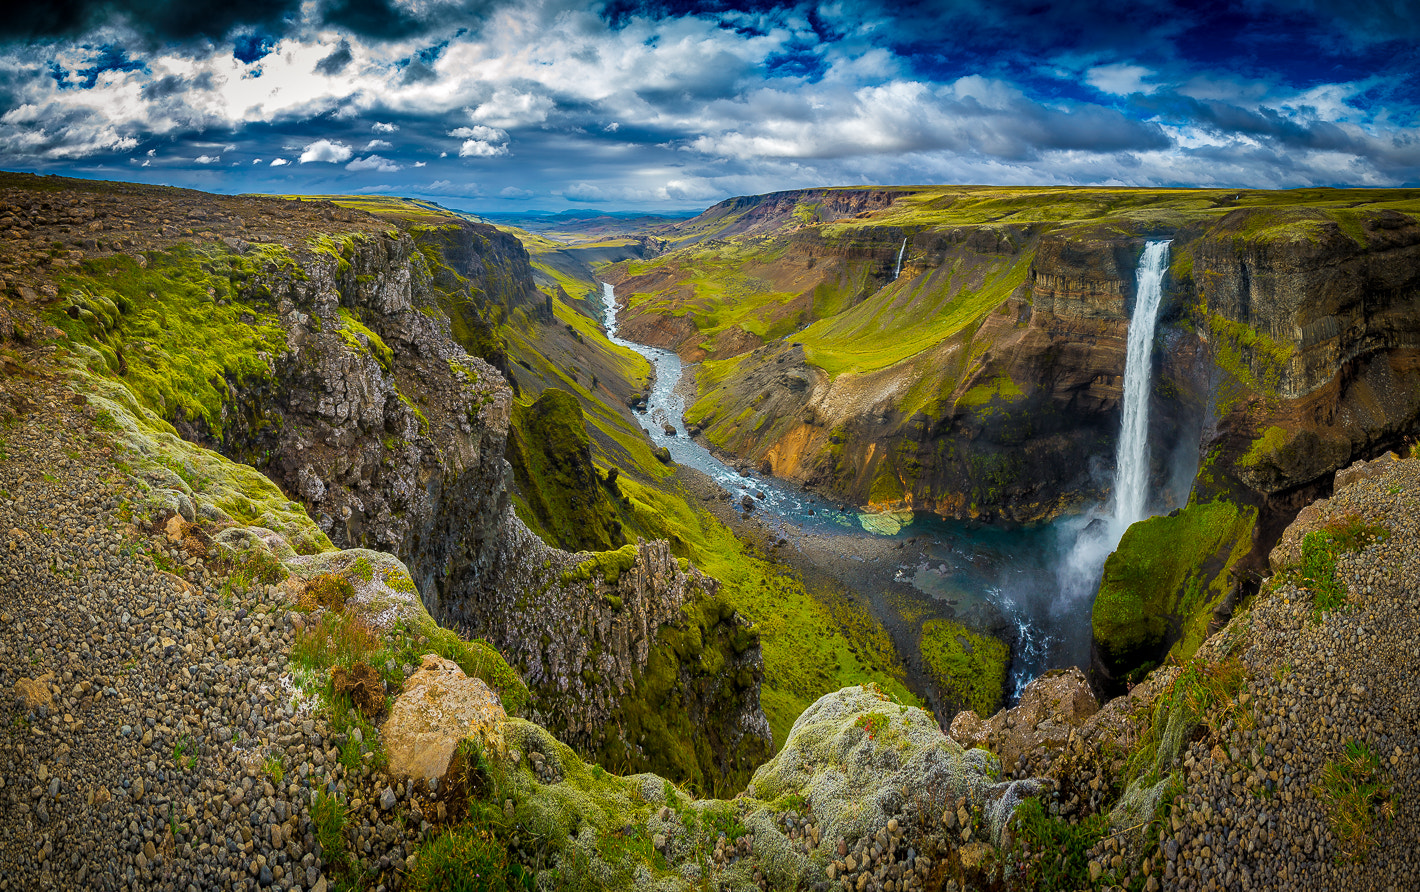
[27,184,771,788]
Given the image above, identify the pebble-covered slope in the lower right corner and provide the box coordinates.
[1160,460,1420,892]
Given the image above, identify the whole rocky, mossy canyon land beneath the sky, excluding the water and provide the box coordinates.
[0,175,1420,891]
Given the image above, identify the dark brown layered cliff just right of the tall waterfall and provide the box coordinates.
[1190,210,1420,508]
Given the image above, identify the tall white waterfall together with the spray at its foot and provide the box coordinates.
[1056,241,1169,609]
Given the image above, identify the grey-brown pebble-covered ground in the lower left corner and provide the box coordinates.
[0,375,429,891]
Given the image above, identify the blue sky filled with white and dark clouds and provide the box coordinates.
[0,0,1420,213]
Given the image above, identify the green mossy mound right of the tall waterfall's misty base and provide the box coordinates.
[1092,496,1257,679]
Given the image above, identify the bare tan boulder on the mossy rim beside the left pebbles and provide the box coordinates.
[381,653,507,781]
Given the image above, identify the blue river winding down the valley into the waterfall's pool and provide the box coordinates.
[602,284,1092,704]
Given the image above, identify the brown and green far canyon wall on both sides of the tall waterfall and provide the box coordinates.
[630,190,1420,535]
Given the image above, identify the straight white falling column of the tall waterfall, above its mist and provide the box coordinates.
[1110,241,1169,535]
